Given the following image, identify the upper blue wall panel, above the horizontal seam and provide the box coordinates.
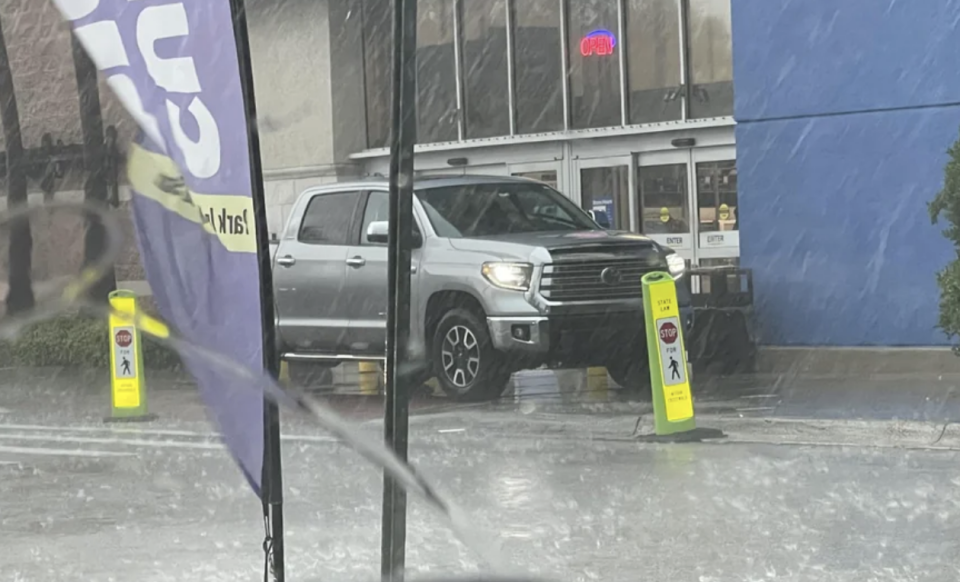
[731,0,960,120]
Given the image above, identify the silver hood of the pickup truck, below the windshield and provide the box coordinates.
[449,230,656,258]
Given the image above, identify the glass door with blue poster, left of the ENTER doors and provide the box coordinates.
[576,157,636,230]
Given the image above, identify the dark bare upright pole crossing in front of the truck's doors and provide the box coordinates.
[380,0,417,582]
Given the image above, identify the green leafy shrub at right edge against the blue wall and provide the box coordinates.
[928,129,960,352]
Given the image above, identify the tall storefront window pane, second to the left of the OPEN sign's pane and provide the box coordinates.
[461,0,510,138]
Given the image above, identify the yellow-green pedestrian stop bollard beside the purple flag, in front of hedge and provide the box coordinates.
[104,289,157,422]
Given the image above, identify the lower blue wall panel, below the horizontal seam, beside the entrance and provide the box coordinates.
[736,108,960,345]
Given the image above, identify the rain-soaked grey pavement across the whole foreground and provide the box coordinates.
[0,373,960,582]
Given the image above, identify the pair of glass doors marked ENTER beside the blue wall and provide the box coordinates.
[636,146,740,267]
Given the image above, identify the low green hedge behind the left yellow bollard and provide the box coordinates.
[0,315,180,370]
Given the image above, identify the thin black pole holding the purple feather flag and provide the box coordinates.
[230,0,285,582]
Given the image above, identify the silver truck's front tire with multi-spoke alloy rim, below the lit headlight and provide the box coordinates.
[431,308,510,402]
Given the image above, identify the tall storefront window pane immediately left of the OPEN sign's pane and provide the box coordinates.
[513,0,563,133]
